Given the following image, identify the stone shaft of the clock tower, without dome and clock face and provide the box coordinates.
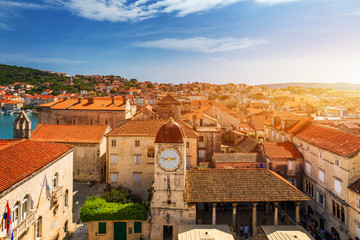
[151,143,196,240]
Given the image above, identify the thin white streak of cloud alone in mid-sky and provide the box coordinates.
[133,37,267,53]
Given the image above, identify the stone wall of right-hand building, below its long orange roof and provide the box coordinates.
[293,137,360,239]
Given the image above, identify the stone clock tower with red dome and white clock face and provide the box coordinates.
[150,118,196,240]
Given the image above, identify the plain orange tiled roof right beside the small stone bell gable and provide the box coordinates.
[31,124,108,143]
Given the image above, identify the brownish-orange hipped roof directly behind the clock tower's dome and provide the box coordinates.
[107,119,197,138]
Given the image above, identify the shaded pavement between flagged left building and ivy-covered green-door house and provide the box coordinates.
[70,182,106,240]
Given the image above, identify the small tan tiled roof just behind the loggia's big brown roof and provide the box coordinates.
[213,153,262,163]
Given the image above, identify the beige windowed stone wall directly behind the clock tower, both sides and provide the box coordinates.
[107,135,197,200]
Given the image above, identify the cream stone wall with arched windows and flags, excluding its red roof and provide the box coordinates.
[0,150,73,240]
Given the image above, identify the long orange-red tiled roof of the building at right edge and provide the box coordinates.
[294,124,360,157]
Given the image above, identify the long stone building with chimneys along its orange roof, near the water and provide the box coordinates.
[37,97,136,129]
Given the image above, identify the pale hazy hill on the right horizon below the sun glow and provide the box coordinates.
[257,82,360,91]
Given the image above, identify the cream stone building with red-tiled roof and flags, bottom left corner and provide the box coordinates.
[0,139,73,240]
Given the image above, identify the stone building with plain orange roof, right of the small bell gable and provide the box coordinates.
[31,124,111,182]
